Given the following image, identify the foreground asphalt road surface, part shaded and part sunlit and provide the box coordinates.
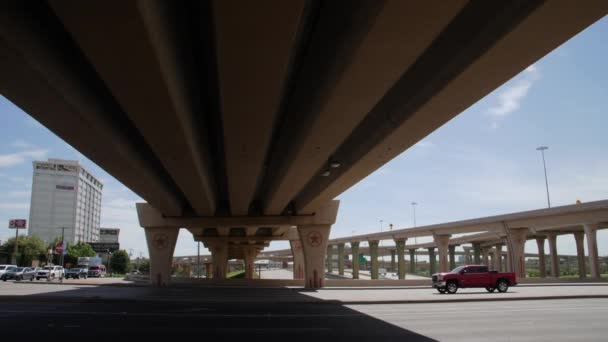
[0,297,608,342]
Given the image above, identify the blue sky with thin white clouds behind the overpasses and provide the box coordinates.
[0,17,608,256]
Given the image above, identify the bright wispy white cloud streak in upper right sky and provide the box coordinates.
[488,64,541,124]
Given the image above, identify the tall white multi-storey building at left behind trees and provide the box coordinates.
[28,159,103,243]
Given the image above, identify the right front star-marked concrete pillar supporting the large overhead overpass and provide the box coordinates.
[298,225,331,289]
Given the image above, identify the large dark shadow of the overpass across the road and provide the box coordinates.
[0,284,434,342]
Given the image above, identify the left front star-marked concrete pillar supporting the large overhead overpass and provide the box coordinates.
[144,227,179,287]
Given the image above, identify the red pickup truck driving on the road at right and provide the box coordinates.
[432,265,517,293]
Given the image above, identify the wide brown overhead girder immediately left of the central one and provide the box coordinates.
[51,1,217,216]
